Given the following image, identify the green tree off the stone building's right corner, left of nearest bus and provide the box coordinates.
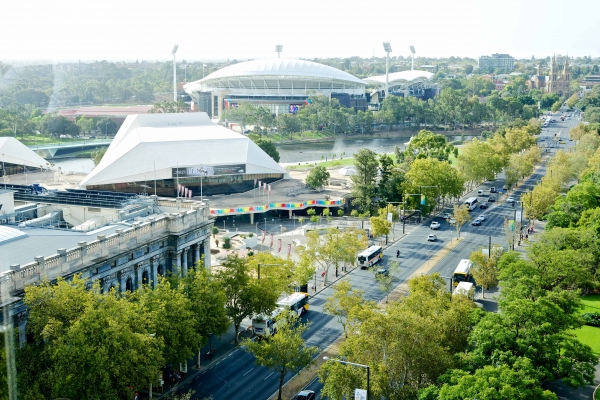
[215,256,281,343]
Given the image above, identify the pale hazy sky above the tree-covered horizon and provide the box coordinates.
[0,0,600,61]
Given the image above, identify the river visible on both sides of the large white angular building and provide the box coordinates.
[53,135,475,174]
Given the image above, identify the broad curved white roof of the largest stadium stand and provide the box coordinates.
[184,58,367,93]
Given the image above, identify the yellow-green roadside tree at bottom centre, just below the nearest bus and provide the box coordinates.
[243,310,319,400]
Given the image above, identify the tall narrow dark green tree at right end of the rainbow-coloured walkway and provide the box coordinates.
[350,149,379,212]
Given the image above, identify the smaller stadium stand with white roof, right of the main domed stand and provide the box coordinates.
[364,70,438,103]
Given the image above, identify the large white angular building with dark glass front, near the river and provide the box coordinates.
[79,113,286,197]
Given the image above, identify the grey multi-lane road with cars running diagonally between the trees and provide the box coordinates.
[182,109,578,400]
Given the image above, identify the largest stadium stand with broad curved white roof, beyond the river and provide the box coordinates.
[184,58,368,119]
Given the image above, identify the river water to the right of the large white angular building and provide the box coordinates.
[276,135,475,163]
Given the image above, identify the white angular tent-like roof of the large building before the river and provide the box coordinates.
[80,113,285,186]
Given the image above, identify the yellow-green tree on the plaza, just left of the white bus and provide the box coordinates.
[300,228,368,286]
